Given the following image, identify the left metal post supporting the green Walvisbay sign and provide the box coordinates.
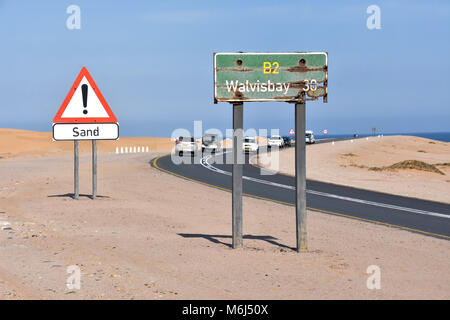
[232,103,244,249]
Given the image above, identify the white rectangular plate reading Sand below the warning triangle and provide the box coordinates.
[53,123,119,140]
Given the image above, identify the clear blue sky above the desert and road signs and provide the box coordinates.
[0,0,450,136]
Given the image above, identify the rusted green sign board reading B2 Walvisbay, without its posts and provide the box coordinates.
[214,52,328,103]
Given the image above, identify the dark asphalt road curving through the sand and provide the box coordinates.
[152,140,450,240]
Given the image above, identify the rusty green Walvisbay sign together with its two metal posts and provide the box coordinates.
[214,52,328,252]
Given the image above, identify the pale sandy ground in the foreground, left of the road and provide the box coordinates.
[0,131,450,299]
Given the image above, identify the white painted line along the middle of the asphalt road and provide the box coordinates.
[200,151,450,219]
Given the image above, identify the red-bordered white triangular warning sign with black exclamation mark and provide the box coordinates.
[53,67,117,123]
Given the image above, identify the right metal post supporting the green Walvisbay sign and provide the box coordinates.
[295,101,308,252]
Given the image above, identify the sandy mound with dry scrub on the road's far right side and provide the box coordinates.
[252,136,450,203]
